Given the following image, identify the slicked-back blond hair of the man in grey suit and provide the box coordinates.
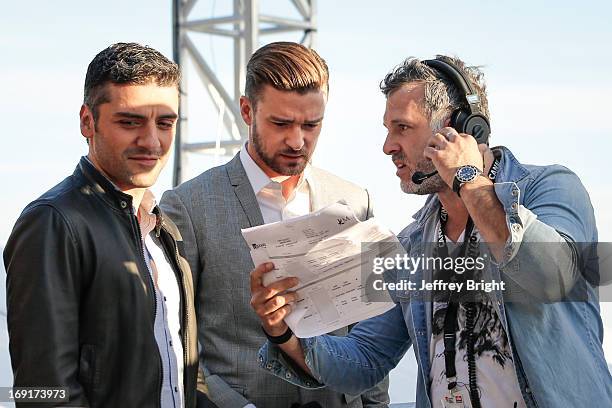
[244,42,329,104]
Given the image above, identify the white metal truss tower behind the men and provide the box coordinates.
[173,0,317,186]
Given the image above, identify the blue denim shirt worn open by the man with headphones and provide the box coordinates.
[259,147,612,408]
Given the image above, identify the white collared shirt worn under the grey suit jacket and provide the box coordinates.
[240,143,312,224]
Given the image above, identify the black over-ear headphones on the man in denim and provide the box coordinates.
[422,59,491,145]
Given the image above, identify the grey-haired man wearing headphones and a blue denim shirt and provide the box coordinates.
[251,56,612,408]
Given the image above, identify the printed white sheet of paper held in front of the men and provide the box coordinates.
[242,203,399,337]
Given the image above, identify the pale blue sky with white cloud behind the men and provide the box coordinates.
[0,0,612,399]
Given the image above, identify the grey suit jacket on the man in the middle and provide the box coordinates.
[160,155,388,408]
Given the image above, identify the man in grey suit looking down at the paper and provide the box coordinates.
[161,42,389,408]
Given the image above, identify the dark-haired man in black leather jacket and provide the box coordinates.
[4,43,212,408]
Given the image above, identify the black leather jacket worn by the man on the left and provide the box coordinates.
[4,158,205,407]
